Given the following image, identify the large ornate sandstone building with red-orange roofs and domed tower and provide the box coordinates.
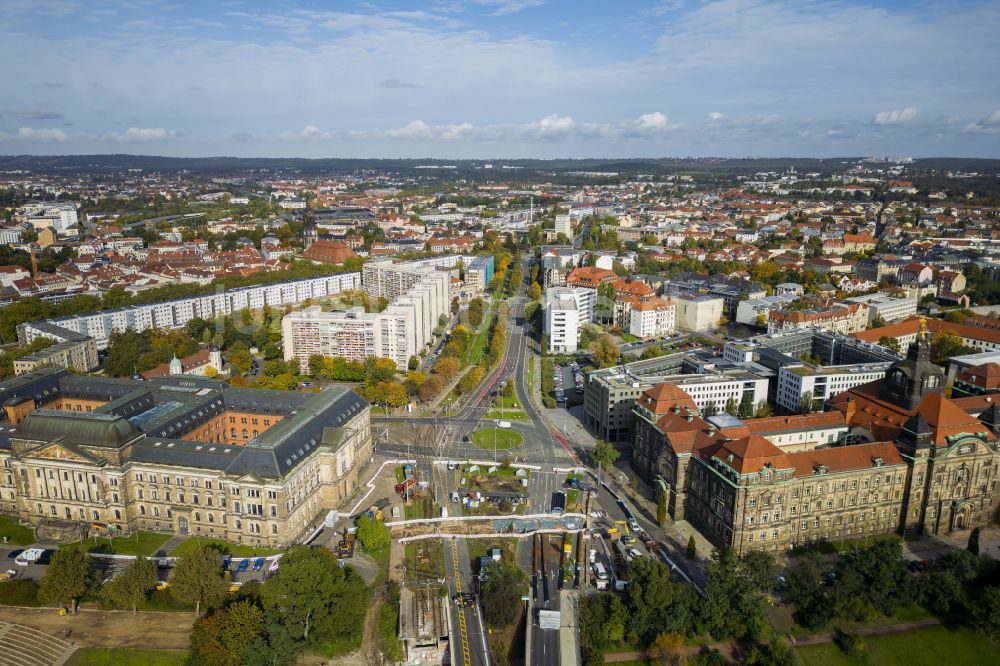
[633,324,1000,552]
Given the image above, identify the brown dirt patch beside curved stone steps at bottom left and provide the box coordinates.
[0,606,197,650]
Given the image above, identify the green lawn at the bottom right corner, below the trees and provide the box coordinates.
[796,627,1000,666]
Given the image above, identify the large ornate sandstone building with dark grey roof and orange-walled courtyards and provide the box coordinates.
[0,368,372,546]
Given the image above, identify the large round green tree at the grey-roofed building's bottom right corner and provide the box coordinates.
[260,546,369,652]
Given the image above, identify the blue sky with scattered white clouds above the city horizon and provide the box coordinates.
[0,0,1000,159]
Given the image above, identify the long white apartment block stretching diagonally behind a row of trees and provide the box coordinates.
[17,273,361,349]
